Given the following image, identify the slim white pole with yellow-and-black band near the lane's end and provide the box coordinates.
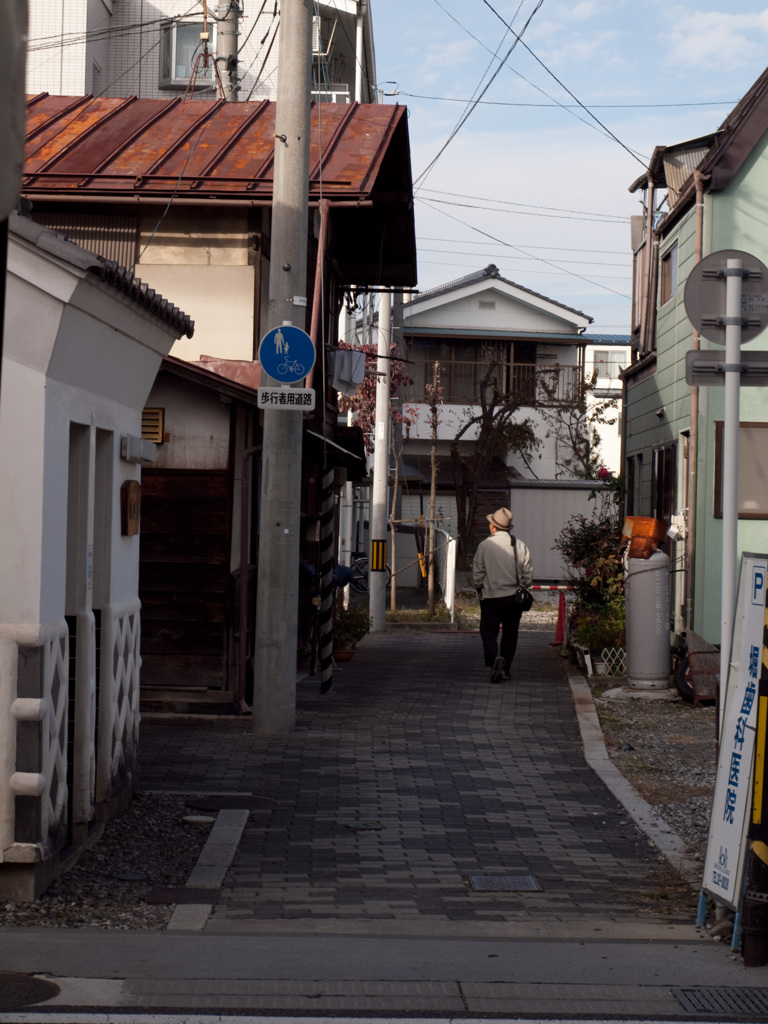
[368,292,394,633]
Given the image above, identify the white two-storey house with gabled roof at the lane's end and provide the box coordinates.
[360,264,629,582]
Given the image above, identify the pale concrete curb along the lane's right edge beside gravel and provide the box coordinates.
[565,666,701,892]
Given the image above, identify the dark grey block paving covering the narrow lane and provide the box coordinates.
[141,631,669,928]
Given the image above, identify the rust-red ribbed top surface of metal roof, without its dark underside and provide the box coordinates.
[24,93,410,202]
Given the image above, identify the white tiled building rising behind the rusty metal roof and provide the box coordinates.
[27,0,377,103]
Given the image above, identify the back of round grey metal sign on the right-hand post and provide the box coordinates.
[683,249,768,345]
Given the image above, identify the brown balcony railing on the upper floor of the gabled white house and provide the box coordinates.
[402,360,584,406]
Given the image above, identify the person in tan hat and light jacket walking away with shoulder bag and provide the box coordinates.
[472,509,534,683]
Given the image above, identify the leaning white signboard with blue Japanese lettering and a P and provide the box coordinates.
[701,553,768,910]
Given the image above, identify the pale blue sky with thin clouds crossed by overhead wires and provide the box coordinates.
[372,0,768,334]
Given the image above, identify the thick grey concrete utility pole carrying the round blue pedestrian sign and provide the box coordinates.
[253,0,313,735]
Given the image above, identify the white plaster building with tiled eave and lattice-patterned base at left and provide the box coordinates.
[0,214,193,900]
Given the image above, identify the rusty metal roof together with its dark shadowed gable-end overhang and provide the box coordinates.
[22,93,417,288]
